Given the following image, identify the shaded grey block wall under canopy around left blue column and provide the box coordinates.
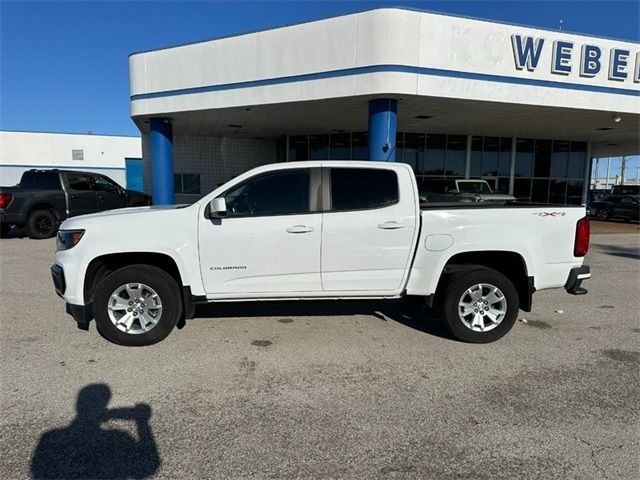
[142,134,276,203]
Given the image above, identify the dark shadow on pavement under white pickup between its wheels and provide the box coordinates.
[194,298,454,340]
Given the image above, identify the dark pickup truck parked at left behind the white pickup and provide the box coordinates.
[0,169,151,238]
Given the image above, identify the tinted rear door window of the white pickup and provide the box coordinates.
[331,168,400,211]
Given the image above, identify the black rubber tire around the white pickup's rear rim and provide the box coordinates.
[439,267,520,343]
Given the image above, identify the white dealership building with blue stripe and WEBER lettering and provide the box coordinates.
[129,8,640,203]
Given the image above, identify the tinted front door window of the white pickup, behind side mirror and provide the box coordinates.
[224,169,310,217]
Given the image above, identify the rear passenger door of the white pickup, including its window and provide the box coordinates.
[322,166,418,292]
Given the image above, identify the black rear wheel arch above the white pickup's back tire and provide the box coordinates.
[436,250,535,312]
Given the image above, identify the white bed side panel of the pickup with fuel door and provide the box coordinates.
[407,206,585,295]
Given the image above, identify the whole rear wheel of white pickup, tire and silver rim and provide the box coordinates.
[442,268,519,343]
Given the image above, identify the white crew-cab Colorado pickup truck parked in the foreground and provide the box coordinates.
[51,161,590,346]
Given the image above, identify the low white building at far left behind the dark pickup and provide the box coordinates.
[0,131,142,187]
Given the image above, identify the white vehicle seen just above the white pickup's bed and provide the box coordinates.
[419,178,515,203]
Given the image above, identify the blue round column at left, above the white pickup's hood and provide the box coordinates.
[149,118,174,205]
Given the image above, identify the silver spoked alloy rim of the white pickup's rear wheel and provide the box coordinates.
[458,283,507,332]
